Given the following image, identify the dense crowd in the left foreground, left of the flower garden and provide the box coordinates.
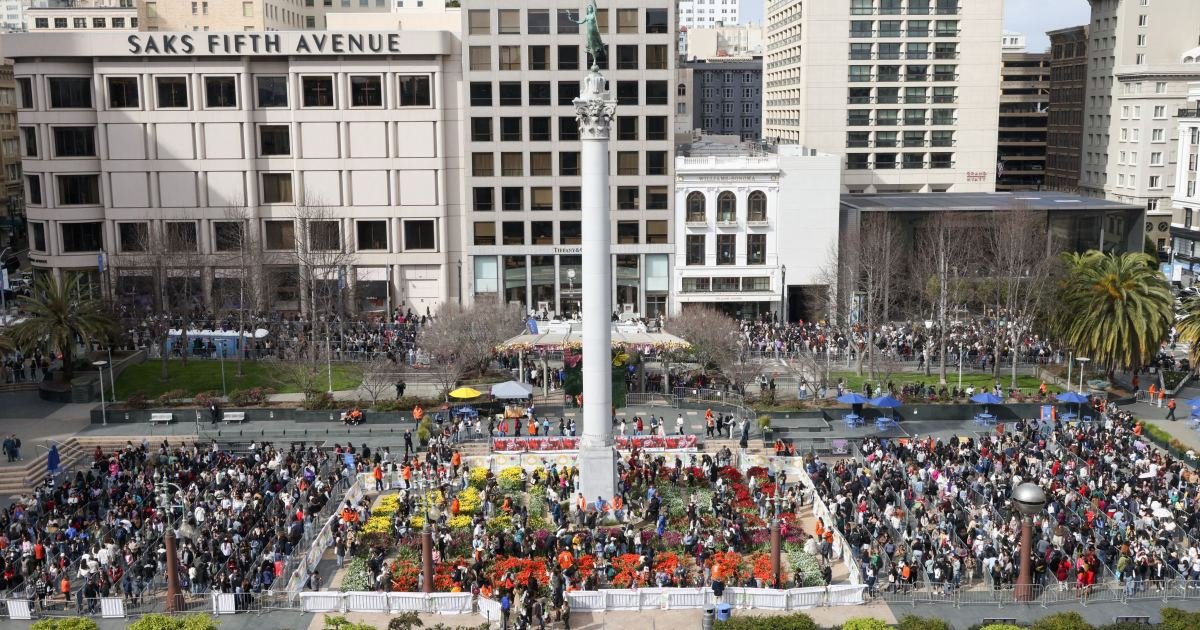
[0,440,340,612]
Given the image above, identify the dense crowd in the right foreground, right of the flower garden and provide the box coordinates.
[806,407,1200,592]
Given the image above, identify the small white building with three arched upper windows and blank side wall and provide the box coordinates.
[671,145,841,322]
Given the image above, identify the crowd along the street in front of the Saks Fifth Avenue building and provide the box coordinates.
[118,307,432,365]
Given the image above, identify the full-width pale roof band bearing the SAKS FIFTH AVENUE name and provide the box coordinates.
[0,30,452,60]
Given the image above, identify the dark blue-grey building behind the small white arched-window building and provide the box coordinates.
[676,58,762,140]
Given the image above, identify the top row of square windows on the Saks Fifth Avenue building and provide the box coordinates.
[17,74,433,109]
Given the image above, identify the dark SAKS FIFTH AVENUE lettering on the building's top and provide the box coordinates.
[126,32,403,55]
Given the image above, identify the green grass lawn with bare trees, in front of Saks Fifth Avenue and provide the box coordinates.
[116,359,362,400]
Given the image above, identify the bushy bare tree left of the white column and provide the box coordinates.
[416,299,524,391]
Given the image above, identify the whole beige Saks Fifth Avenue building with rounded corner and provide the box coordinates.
[4,31,462,314]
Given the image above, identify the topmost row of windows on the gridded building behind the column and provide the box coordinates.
[467,8,671,35]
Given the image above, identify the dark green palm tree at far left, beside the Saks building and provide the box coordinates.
[12,274,112,380]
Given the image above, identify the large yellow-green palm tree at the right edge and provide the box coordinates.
[1056,251,1174,376]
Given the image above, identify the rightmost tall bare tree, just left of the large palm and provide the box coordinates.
[986,205,1056,388]
